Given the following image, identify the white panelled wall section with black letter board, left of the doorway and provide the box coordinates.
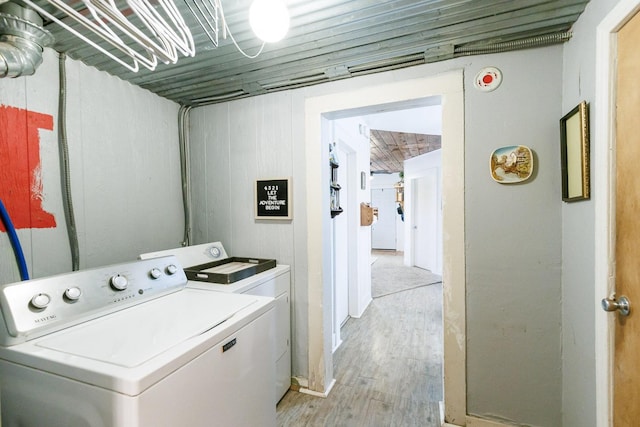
[190,92,304,375]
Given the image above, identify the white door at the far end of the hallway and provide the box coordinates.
[371,188,398,250]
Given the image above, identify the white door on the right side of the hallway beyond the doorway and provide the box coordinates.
[413,169,439,271]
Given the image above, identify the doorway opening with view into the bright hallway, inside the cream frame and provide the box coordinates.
[329,100,443,414]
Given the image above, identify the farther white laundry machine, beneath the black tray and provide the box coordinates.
[140,242,291,403]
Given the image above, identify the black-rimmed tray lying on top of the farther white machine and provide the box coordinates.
[184,257,276,285]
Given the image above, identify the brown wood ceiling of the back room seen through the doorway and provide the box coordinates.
[370,129,442,174]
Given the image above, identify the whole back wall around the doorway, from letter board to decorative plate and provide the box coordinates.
[192,46,562,426]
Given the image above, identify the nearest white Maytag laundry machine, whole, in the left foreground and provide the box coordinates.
[0,257,276,427]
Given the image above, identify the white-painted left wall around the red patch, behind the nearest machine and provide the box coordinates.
[0,49,184,283]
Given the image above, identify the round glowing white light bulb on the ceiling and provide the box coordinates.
[249,0,289,43]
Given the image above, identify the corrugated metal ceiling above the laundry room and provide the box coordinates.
[39,0,588,105]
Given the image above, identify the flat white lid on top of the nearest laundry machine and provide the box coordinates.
[36,289,255,368]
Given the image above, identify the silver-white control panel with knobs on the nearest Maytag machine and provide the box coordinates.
[0,256,187,346]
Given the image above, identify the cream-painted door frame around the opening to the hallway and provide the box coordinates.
[305,70,466,420]
